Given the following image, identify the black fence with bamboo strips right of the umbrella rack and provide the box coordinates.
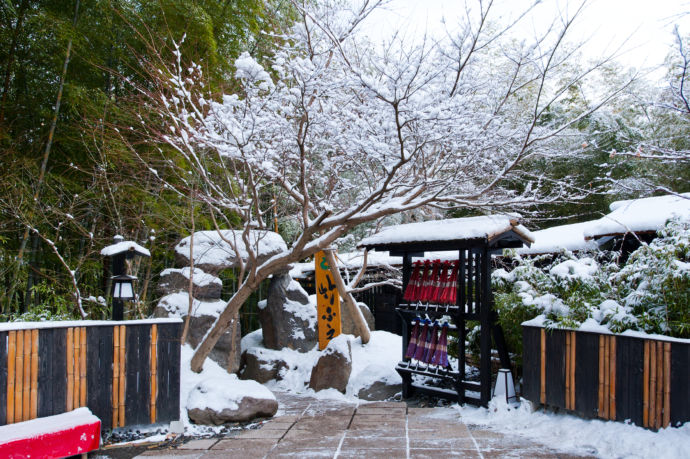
[522,327,690,429]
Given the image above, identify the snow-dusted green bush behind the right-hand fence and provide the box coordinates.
[492,220,690,342]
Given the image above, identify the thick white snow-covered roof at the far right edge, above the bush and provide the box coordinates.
[585,193,690,239]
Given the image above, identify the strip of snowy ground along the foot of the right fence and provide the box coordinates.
[454,398,690,458]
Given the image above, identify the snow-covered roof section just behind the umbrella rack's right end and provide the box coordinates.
[517,221,599,255]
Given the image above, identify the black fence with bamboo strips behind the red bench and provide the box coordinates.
[0,319,182,430]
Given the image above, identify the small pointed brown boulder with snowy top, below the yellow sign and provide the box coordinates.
[309,335,352,394]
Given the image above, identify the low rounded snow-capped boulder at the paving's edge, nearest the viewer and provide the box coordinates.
[187,377,278,425]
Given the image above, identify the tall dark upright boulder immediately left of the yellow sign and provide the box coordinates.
[259,273,318,352]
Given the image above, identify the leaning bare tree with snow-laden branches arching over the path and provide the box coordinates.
[133,0,636,371]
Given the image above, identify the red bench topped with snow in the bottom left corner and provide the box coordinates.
[0,408,101,458]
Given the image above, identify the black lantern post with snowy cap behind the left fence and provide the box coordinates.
[101,236,151,320]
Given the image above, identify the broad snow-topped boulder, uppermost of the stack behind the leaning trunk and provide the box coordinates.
[175,230,287,272]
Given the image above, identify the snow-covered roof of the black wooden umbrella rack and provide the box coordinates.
[359,215,534,252]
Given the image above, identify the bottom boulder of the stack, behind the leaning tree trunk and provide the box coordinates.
[153,292,242,373]
